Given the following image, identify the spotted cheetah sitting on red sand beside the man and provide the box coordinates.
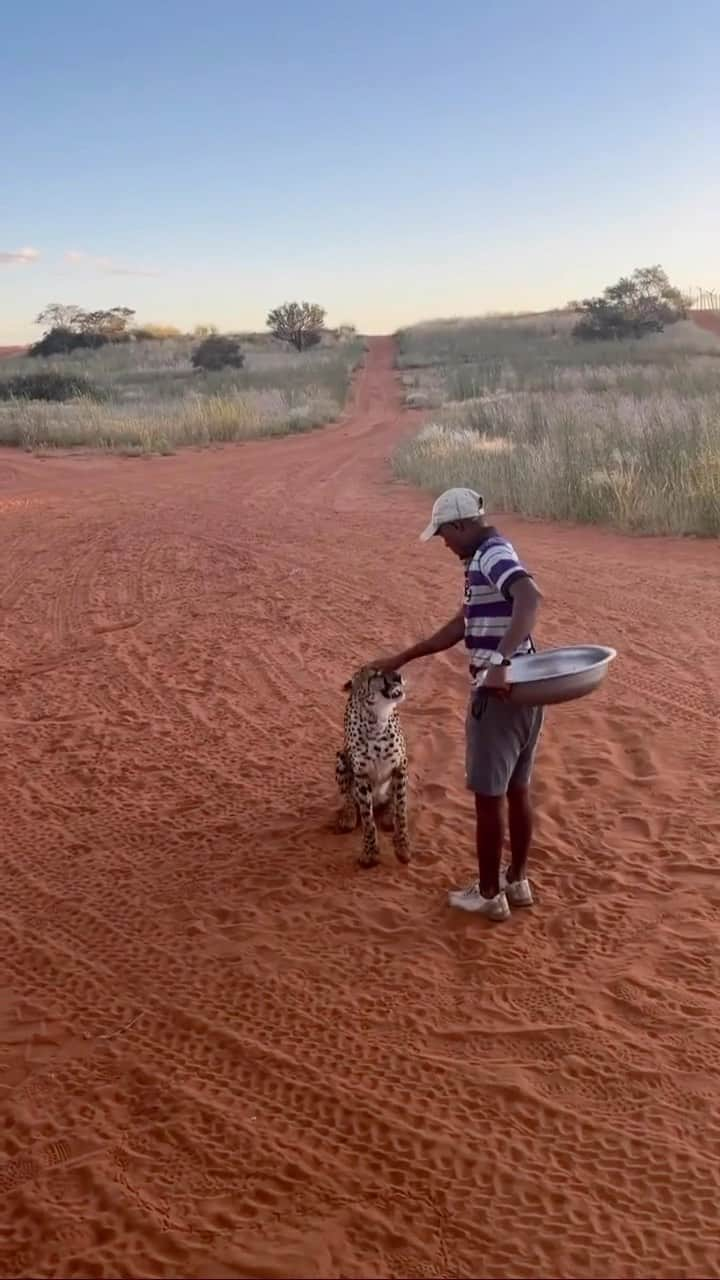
[336,667,410,867]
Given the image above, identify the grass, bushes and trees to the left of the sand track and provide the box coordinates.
[0,303,364,453]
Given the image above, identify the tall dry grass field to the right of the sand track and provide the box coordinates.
[395,325,720,536]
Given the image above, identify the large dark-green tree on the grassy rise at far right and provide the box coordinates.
[573,266,689,340]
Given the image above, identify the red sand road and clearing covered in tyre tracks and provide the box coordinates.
[0,339,720,1277]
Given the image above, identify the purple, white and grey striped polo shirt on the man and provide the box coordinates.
[465,529,533,676]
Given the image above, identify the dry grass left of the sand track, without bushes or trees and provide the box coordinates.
[0,339,363,453]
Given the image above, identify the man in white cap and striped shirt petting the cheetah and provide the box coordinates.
[368,489,543,920]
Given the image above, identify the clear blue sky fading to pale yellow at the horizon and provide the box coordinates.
[0,0,720,343]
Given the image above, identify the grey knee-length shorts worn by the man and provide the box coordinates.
[465,694,543,796]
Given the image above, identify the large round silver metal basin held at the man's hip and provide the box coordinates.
[502,644,618,707]
